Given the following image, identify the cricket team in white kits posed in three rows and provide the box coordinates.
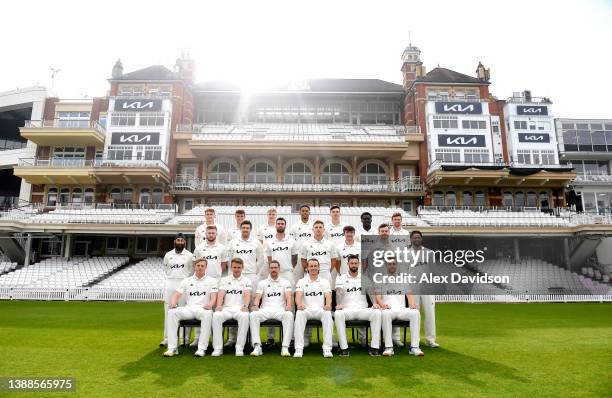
[160,205,438,358]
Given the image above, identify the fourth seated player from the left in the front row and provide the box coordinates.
[293,258,334,358]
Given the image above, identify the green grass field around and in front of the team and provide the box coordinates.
[0,301,612,397]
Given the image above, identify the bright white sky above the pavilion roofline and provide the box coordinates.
[0,0,612,118]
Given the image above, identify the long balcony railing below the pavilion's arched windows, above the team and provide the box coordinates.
[172,174,423,192]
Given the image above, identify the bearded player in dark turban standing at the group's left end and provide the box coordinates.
[159,232,193,346]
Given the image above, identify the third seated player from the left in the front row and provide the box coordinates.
[250,260,293,357]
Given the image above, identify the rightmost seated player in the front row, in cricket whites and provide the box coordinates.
[376,260,425,357]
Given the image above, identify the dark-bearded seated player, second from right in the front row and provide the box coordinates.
[334,254,382,357]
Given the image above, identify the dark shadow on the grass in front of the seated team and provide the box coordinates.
[119,344,528,394]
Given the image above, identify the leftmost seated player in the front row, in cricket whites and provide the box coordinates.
[164,258,218,357]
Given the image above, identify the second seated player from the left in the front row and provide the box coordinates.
[211,258,253,357]
